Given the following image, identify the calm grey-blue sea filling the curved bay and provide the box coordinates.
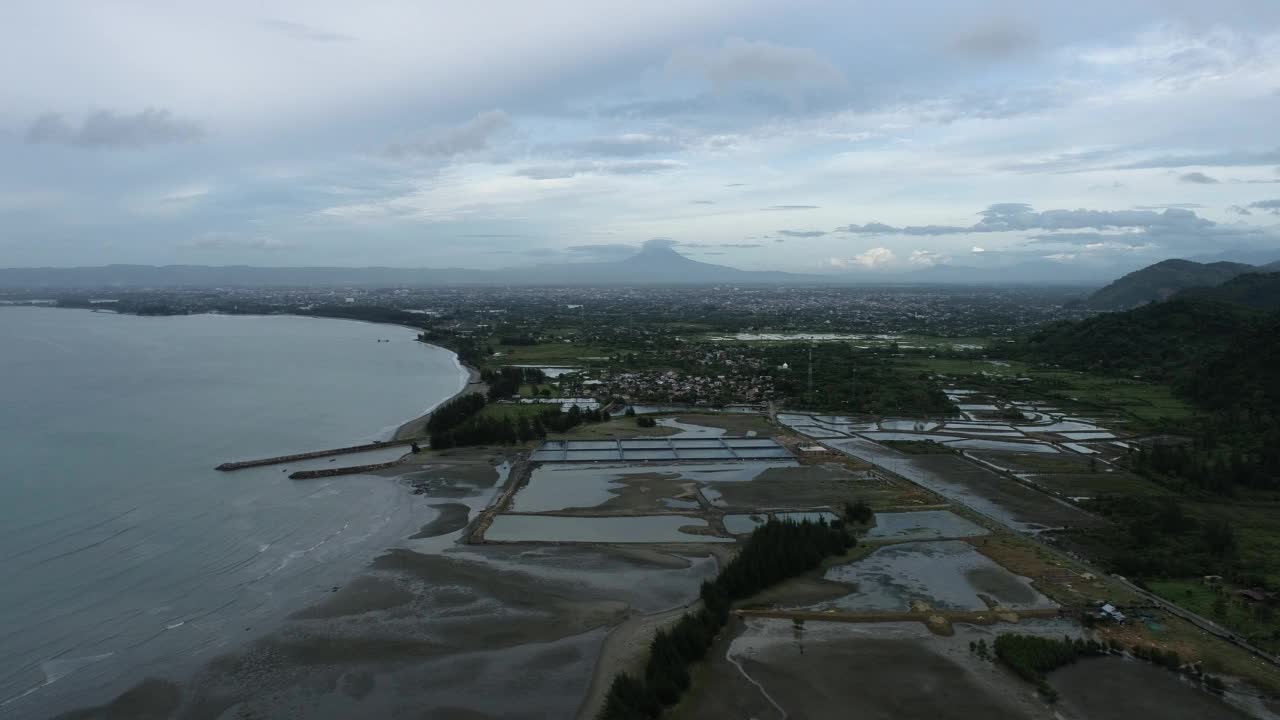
[0,307,466,717]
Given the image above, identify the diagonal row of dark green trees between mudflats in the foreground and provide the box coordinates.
[599,520,854,720]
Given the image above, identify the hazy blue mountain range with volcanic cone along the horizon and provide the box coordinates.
[0,245,1280,288]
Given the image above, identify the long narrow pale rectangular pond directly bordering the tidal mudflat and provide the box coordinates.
[485,515,733,543]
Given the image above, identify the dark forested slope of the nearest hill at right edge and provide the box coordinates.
[1020,294,1280,495]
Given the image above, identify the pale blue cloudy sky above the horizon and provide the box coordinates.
[0,0,1280,274]
